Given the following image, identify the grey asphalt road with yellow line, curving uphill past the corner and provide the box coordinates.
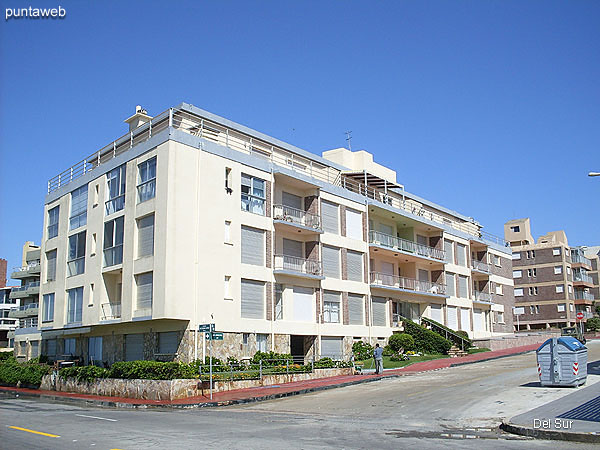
[0,341,600,449]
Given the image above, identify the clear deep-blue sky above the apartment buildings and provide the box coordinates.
[0,0,600,284]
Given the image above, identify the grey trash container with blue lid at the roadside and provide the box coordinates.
[536,336,587,386]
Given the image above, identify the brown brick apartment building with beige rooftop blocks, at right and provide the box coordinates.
[504,218,597,330]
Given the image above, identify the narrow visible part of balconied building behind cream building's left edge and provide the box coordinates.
[8,241,41,360]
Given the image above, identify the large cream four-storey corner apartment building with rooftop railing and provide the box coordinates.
[39,104,514,363]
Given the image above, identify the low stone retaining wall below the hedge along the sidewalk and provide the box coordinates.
[40,367,353,400]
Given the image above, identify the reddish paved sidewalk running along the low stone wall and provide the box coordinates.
[0,344,539,408]
